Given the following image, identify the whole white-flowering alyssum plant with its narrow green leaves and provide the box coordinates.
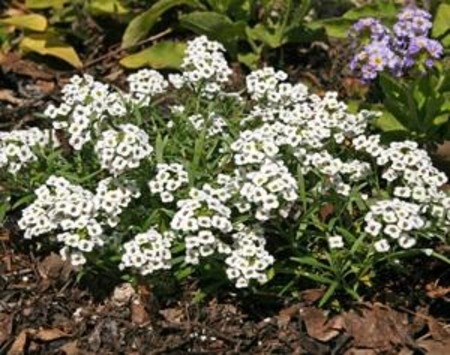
[0,37,450,303]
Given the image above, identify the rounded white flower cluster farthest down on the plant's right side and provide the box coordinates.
[364,199,427,252]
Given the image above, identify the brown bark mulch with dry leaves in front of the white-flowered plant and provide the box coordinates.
[0,242,450,355]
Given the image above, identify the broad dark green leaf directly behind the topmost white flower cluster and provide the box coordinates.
[180,11,245,47]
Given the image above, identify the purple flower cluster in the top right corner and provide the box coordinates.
[349,6,443,81]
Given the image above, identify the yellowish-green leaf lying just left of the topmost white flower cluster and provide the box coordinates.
[120,41,186,69]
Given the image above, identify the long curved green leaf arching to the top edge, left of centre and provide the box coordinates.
[122,0,199,48]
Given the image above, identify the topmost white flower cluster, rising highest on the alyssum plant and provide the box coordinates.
[169,36,232,97]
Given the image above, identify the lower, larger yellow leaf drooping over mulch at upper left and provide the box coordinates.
[20,36,83,68]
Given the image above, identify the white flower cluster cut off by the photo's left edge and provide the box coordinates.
[0,128,58,174]
